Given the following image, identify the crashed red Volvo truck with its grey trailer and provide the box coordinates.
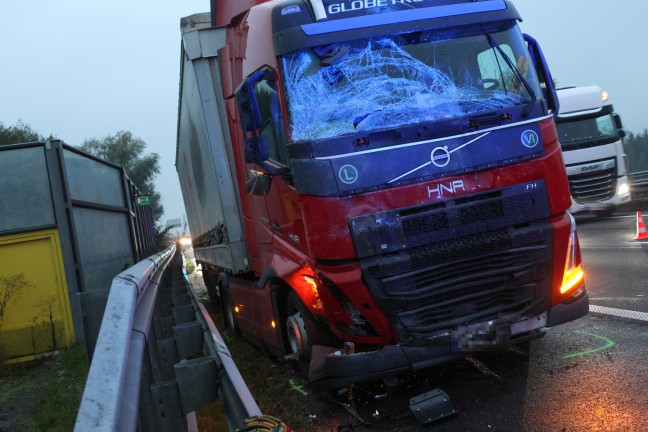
[176,0,589,388]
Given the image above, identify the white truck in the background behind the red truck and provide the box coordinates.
[556,85,630,216]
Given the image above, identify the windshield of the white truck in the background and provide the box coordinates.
[556,114,619,150]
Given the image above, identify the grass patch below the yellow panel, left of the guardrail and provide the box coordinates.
[0,345,89,432]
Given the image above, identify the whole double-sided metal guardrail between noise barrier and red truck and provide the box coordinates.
[74,246,261,432]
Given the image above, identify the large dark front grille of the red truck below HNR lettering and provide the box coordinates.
[350,182,552,346]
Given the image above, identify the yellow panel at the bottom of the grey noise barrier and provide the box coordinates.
[0,229,74,362]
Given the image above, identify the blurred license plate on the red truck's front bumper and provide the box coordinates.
[450,322,511,352]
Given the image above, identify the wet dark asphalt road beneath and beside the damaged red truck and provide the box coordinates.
[318,212,648,432]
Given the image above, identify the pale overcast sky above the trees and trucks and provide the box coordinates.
[0,0,648,226]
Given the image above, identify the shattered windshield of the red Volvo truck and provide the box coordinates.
[282,25,541,142]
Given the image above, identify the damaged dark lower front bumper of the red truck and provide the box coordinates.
[310,292,589,390]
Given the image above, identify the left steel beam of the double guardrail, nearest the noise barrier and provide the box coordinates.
[75,246,175,432]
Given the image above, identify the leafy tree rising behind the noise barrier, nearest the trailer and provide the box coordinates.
[81,131,164,221]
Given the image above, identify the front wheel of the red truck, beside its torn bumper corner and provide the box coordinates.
[286,291,325,375]
